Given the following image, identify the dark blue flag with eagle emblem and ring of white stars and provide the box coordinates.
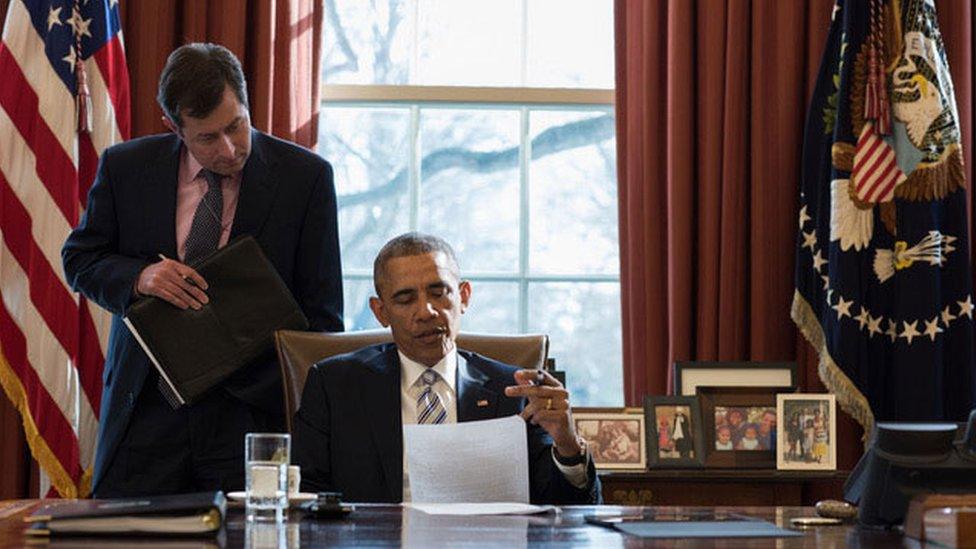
[792,0,976,436]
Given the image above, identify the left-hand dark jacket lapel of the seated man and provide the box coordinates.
[359,345,403,501]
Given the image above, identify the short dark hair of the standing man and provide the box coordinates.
[156,42,248,127]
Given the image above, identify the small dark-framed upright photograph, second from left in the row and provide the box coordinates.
[644,395,705,468]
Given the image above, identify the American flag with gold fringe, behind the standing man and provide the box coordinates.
[0,0,129,497]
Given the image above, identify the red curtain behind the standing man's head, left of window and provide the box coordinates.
[0,0,323,499]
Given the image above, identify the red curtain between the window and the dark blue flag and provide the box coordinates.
[615,0,976,467]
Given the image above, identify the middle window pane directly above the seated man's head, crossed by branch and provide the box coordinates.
[419,109,519,273]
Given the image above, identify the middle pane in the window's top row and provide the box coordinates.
[416,0,522,86]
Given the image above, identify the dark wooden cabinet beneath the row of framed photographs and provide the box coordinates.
[600,469,849,507]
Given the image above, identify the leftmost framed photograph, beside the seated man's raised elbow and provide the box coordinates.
[573,408,647,471]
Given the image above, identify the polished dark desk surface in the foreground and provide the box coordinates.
[0,501,920,549]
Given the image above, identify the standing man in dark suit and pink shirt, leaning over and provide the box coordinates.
[62,44,342,497]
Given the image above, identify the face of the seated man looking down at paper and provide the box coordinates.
[369,252,471,366]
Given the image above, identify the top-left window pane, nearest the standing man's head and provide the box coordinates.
[322,0,414,84]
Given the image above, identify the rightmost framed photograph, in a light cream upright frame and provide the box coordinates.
[776,394,837,471]
